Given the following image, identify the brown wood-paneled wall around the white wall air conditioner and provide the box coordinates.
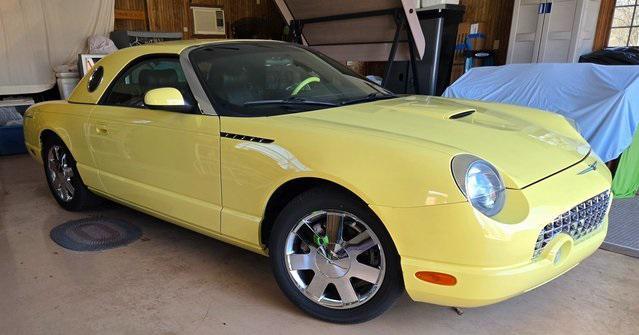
[115,0,284,38]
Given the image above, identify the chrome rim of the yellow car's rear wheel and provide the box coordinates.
[47,144,75,202]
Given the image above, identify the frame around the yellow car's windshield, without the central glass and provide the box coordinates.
[181,40,397,117]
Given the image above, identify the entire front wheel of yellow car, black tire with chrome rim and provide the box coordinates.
[269,188,404,323]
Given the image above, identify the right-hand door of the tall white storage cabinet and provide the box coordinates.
[537,0,577,63]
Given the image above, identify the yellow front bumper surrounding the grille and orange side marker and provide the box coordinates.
[371,157,611,307]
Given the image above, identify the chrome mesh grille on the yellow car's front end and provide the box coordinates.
[533,191,610,258]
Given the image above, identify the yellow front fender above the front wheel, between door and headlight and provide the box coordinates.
[221,117,466,217]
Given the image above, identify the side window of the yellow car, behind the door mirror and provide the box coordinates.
[102,57,193,108]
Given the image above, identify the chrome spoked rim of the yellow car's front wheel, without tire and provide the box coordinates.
[285,210,386,309]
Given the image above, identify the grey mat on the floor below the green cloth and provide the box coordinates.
[601,197,639,258]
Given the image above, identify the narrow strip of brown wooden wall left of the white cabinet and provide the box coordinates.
[460,0,515,65]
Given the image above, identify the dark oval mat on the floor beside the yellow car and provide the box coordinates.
[51,218,142,251]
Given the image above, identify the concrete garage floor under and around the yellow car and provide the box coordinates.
[0,156,639,334]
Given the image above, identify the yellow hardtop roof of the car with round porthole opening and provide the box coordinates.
[68,39,284,104]
